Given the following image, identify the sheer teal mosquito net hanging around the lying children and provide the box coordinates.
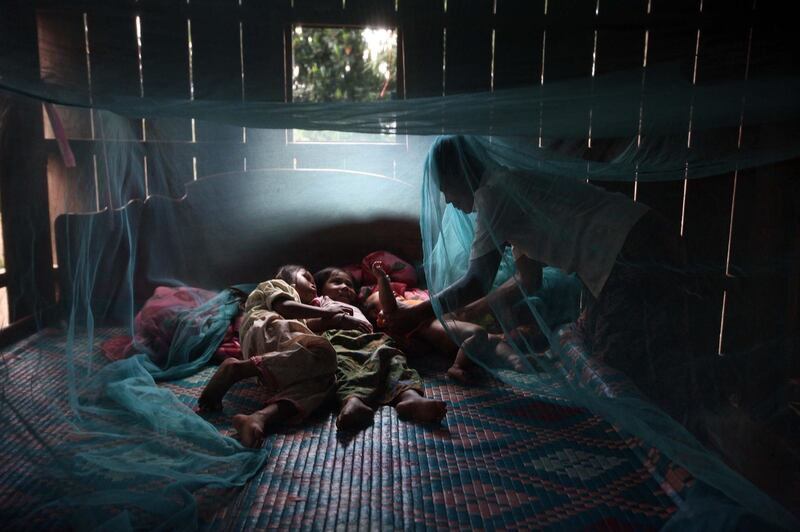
[0,0,800,529]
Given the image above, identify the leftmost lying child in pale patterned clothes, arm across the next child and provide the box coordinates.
[199,265,372,447]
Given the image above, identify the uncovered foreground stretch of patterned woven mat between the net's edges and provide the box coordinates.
[173,363,688,530]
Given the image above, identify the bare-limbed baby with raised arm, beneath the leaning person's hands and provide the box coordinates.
[364,261,520,384]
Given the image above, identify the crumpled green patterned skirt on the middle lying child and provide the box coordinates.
[322,329,424,408]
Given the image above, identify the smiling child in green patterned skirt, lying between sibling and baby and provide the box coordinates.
[314,268,447,430]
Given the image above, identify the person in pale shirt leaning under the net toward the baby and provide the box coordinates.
[387,136,690,417]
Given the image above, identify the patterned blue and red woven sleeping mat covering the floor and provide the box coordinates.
[0,329,691,530]
